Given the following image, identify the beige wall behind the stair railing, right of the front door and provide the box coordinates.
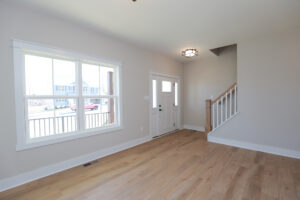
[183,46,237,127]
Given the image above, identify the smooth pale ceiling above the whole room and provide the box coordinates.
[11,0,300,61]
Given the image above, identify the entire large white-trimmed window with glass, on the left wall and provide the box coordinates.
[14,41,121,149]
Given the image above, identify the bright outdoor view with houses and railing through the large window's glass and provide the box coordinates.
[24,53,119,139]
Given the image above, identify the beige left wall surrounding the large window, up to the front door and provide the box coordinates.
[0,2,182,179]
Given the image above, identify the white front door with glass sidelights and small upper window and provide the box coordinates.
[151,76,179,137]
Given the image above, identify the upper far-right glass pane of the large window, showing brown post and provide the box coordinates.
[100,67,114,95]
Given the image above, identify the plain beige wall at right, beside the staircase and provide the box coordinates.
[212,29,300,151]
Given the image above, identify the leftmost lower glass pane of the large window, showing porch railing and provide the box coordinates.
[28,99,54,139]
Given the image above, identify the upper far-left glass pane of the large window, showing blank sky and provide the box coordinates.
[25,55,53,95]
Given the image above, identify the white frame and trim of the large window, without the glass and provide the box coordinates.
[13,40,123,151]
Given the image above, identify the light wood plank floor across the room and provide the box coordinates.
[0,130,300,200]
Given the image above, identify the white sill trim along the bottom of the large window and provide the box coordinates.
[16,125,124,151]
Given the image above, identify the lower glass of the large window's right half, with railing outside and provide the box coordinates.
[84,98,116,129]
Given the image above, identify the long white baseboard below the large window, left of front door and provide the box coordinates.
[0,137,152,192]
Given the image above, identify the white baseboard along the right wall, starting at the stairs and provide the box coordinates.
[207,134,300,159]
